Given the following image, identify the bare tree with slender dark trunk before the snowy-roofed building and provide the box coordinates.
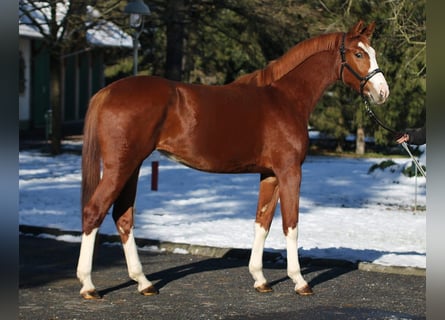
[19,0,119,154]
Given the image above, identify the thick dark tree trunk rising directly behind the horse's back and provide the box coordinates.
[165,0,185,81]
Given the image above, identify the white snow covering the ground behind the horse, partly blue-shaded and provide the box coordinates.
[19,142,426,268]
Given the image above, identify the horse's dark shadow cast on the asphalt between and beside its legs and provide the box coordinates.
[99,250,356,296]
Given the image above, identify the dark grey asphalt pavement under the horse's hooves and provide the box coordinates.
[18,233,426,320]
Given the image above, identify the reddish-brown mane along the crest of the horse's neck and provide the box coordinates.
[234,32,342,86]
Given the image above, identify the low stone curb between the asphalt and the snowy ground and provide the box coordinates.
[19,225,426,277]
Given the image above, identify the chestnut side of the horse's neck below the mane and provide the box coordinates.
[273,50,341,113]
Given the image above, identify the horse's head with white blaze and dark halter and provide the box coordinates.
[340,21,389,104]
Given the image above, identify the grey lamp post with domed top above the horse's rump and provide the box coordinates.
[124,0,150,75]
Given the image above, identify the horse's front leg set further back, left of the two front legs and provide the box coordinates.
[249,175,278,292]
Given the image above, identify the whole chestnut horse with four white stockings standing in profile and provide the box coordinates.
[77,21,389,299]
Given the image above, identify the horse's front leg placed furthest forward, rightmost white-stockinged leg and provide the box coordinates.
[279,166,313,295]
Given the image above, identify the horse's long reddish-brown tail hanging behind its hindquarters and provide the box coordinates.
[82,93,102,210]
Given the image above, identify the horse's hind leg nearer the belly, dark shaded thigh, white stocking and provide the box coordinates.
[113,167,158,295]
